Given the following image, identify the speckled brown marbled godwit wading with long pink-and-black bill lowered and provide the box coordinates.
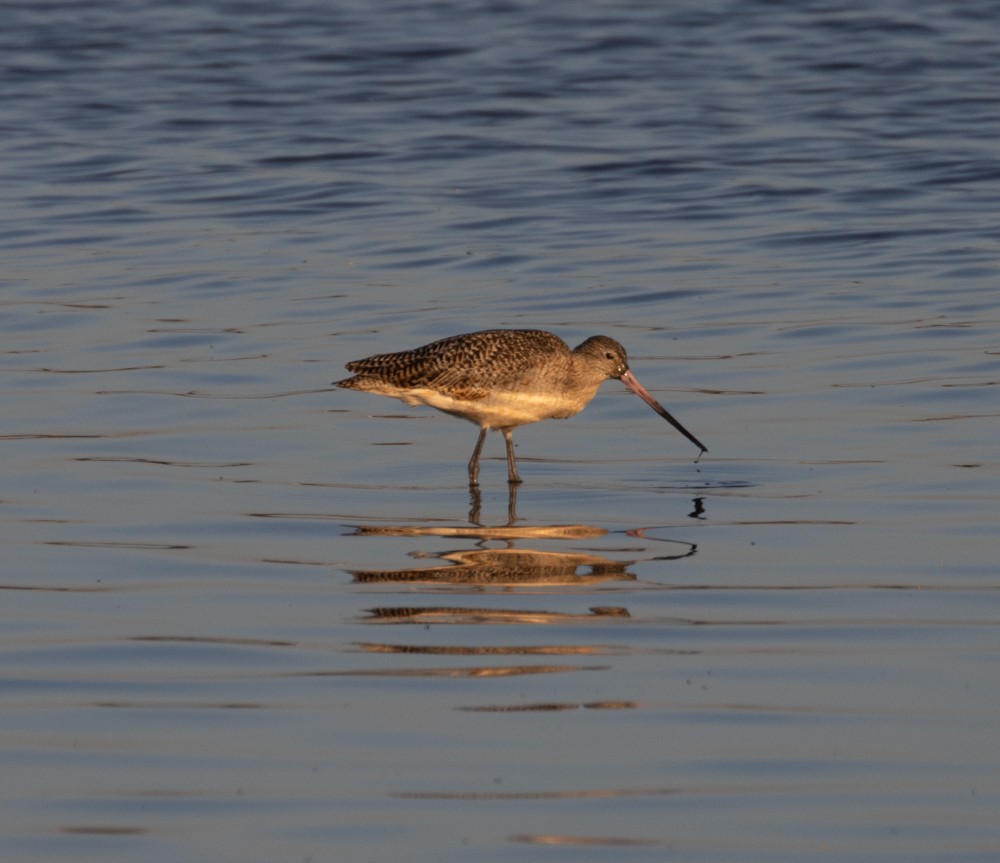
[334,330,708,486]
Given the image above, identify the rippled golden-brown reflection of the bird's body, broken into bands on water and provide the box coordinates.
[348,519,696,713]
